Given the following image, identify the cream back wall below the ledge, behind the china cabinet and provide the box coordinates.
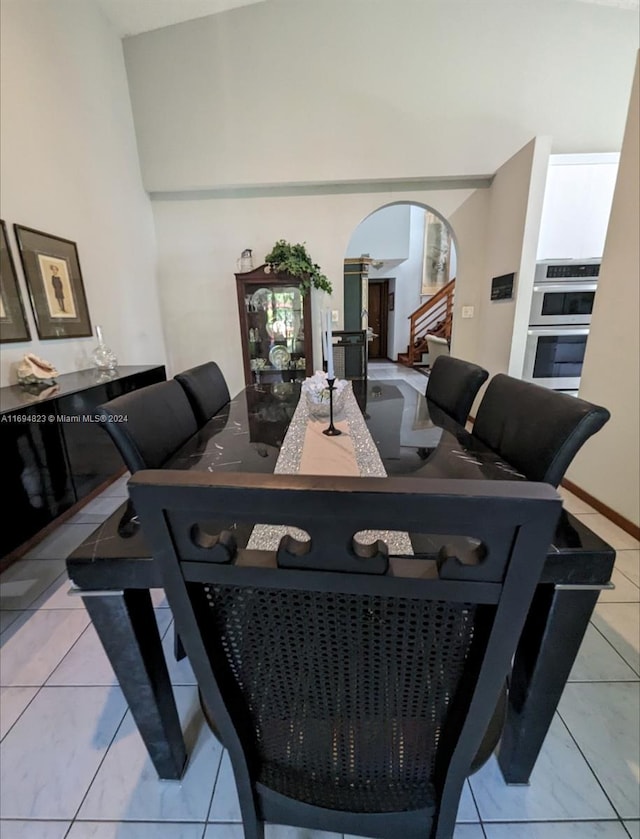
[152,189,471,393]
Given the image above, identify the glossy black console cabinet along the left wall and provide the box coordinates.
[0,366,166,558]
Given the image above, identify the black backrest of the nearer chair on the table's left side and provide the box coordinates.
[97,381,198,474]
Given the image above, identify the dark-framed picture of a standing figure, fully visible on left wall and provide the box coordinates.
[13,224,93,340]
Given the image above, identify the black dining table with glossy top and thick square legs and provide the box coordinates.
[67,380,615,784]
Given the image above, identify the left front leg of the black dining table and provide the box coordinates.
[82,589,187,780]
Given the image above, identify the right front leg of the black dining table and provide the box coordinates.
[498,585,600,784]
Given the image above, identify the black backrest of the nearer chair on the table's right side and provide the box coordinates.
[472,373,611,486]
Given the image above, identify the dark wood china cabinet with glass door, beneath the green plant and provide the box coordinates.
[235,265,313,385]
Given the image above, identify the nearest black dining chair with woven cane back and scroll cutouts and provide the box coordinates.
[130,470,561,839]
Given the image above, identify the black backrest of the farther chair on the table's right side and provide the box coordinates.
[425,355,489,425]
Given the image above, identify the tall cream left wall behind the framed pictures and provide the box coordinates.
[0,0,164,385]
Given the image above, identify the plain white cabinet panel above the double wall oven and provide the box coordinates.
[538,153,620,260]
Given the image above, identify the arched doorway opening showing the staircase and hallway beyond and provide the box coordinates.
[344,202,457,364]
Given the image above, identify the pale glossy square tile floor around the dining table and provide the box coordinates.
[0,362,640,839]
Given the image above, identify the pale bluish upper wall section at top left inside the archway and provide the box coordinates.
[345,204,411,260]
